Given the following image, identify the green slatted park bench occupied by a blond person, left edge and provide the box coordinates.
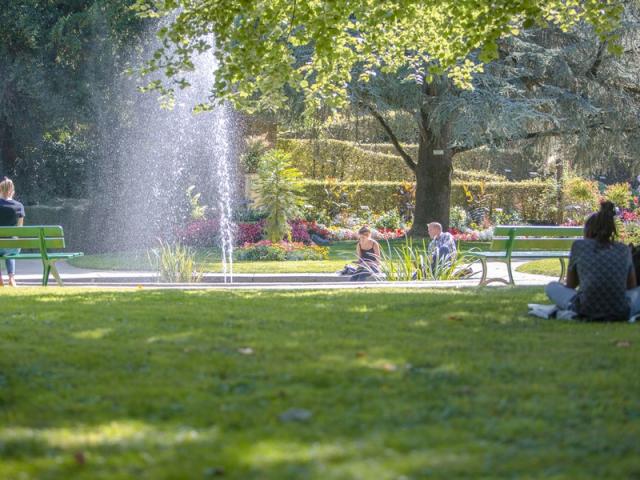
[0,225,83,286]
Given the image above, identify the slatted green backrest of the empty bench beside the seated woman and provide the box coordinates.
[490,225,584,252]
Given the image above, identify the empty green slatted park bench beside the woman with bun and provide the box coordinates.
[470,225,583,285]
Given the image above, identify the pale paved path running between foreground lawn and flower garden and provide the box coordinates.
[3,260,554,289]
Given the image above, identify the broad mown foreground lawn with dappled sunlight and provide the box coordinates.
[0,288,640,480]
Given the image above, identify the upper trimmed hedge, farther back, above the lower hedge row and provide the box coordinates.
[277,139,505,182]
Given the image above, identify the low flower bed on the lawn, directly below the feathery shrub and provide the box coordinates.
[234,240,329,261]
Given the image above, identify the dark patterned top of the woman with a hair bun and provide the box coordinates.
[569,239,633,321]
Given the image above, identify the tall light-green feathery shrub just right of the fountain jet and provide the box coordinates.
[257,150,304,242]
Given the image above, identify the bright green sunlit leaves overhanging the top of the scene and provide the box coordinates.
[136,0,622,111]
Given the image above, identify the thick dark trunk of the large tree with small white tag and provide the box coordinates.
[409,92,453,237]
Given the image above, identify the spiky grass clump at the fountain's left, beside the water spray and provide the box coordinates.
[147,240,204,283]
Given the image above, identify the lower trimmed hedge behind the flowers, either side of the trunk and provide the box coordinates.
[304,180,556,222]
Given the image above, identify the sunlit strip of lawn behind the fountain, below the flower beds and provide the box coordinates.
[68,240,488,273]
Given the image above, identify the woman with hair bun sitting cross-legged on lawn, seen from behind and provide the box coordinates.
[545,202,640,321]
